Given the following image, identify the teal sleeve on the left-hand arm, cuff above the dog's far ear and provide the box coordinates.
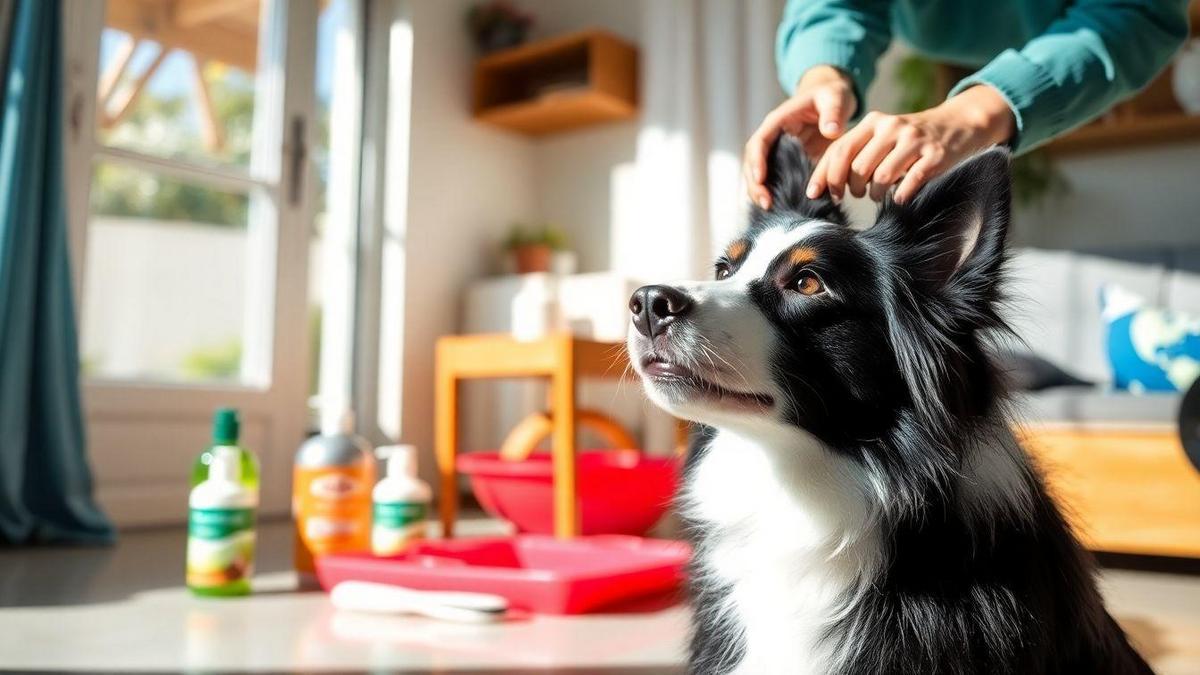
[775,0,892,115]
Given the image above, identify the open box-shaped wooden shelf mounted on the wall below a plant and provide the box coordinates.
[474,30,637,136]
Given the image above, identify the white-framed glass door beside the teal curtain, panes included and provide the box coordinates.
[66,0,343,525]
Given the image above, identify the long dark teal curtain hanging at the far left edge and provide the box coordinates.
[0,0,113,544]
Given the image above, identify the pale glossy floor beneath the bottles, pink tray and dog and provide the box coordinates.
[0,522,1200,675]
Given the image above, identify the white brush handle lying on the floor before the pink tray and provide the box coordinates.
[329,581,509,623]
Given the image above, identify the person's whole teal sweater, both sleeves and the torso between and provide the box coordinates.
[775,0,1188,151]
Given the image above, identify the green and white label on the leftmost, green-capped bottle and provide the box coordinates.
[187,508,254,589]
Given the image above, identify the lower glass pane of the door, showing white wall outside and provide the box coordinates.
[83,163,256,382]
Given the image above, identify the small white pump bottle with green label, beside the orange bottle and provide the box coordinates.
[371,446,432,555]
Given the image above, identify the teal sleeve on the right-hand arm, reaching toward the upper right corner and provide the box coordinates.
[950,0,1188,153]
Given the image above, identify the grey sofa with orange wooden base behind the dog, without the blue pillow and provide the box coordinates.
[1007,246,1200,557]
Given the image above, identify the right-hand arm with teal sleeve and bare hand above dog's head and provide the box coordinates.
[808,0,1188,202]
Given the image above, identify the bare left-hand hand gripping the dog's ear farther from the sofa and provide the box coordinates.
[743,66,858,209]
